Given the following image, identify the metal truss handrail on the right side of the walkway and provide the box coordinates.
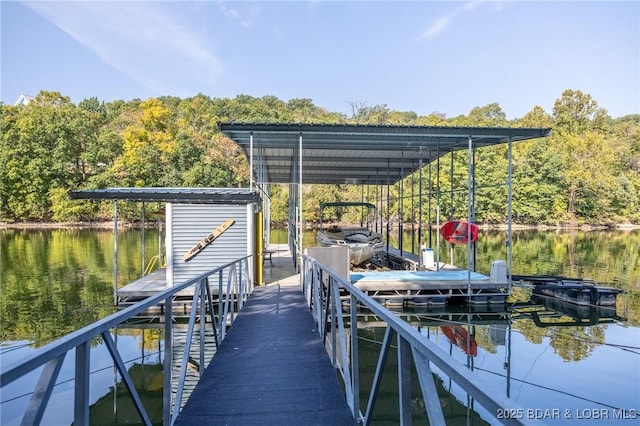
[301,255,542,425]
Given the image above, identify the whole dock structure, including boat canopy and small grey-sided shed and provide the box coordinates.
[71,123,550,303]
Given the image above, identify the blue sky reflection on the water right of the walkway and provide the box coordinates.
[358,290,640,424]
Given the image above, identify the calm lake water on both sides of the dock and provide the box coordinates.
[0,229,640,426]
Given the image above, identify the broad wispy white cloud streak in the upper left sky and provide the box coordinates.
[23,1,223,96]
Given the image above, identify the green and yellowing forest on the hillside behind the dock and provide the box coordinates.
[0,90,640,226]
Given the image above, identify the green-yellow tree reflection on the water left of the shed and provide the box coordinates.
[0,229,158,346]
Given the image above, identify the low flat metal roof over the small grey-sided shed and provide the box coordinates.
[69,188,260,204]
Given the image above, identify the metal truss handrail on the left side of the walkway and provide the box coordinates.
[0,255,253,425]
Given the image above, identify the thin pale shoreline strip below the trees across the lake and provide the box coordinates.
[5,220,640,232]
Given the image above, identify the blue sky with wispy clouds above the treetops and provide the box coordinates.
[0,0,640,119]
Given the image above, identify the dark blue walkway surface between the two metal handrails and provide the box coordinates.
[175,284,356,426]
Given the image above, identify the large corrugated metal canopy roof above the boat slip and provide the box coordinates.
[220,123,551,185]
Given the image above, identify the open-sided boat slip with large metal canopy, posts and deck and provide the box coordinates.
[220,123,550,303]
